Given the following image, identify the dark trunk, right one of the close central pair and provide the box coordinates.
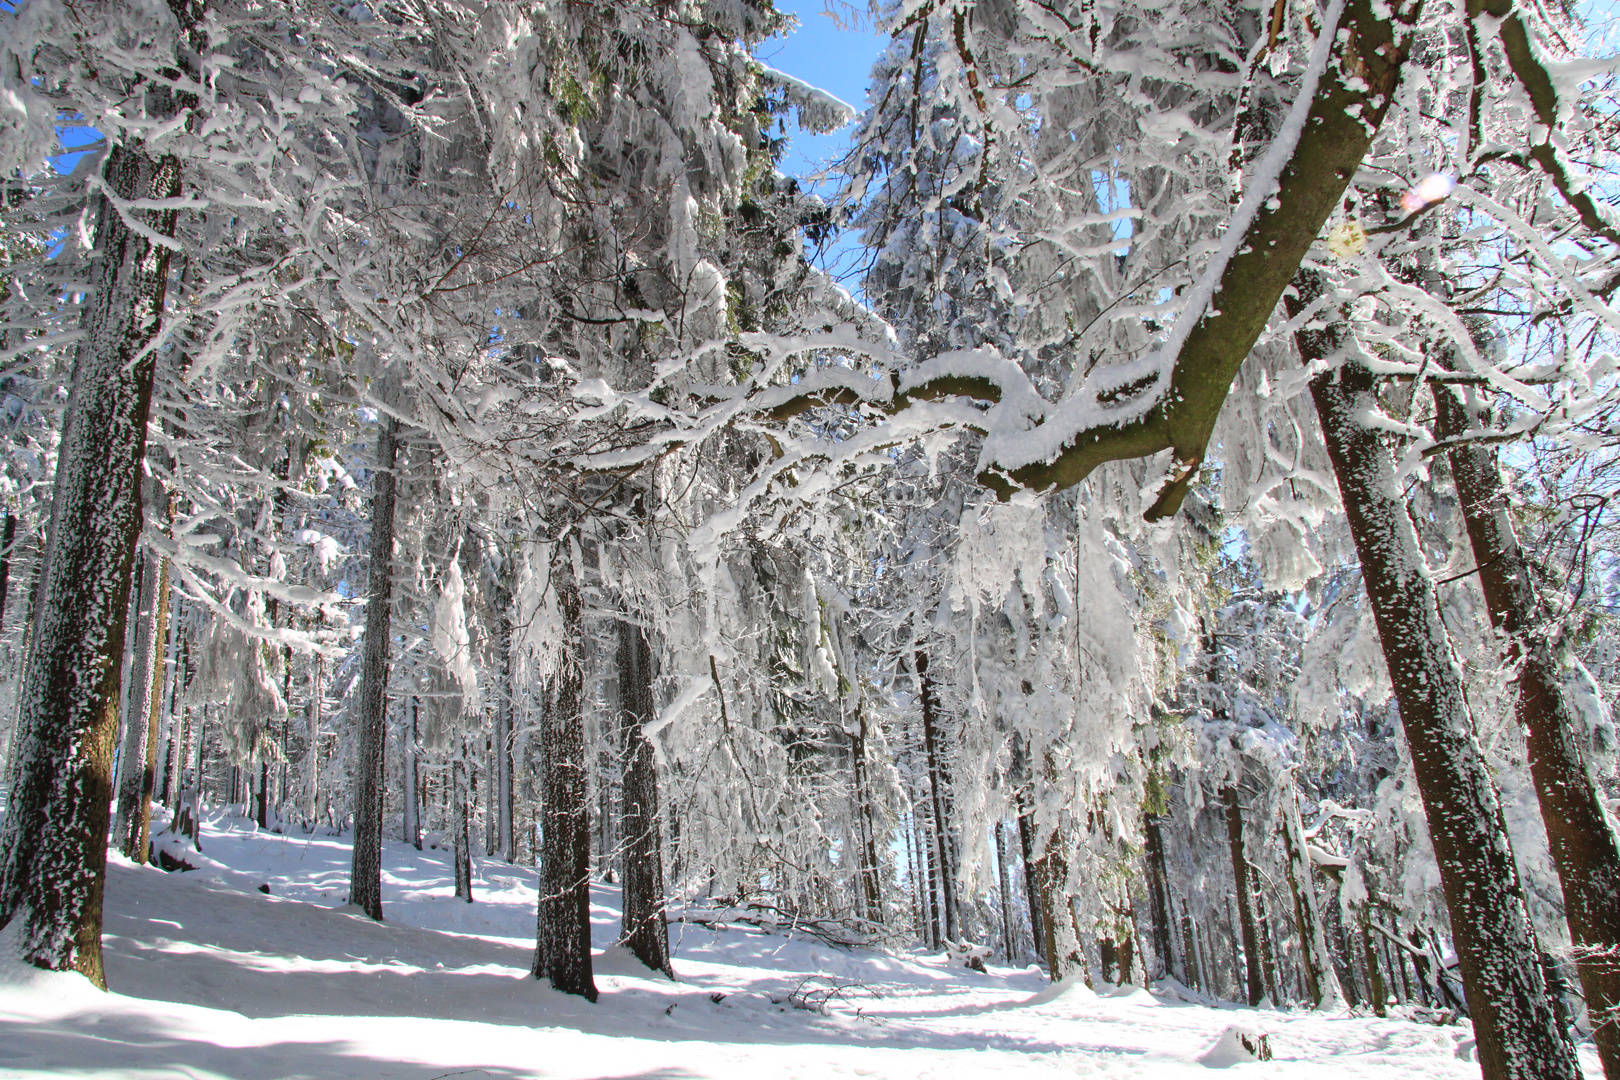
[619,619,674,978]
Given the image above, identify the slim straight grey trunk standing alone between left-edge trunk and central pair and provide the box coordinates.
[348,413,399,920]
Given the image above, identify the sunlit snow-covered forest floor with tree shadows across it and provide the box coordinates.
[0,809,1601,1080]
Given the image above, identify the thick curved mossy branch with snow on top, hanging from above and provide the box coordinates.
[745,0,1421,520]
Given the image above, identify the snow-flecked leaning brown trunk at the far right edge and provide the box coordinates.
[1434,385,1620,1080]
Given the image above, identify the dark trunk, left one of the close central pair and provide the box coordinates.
[535,569,596,1001]
